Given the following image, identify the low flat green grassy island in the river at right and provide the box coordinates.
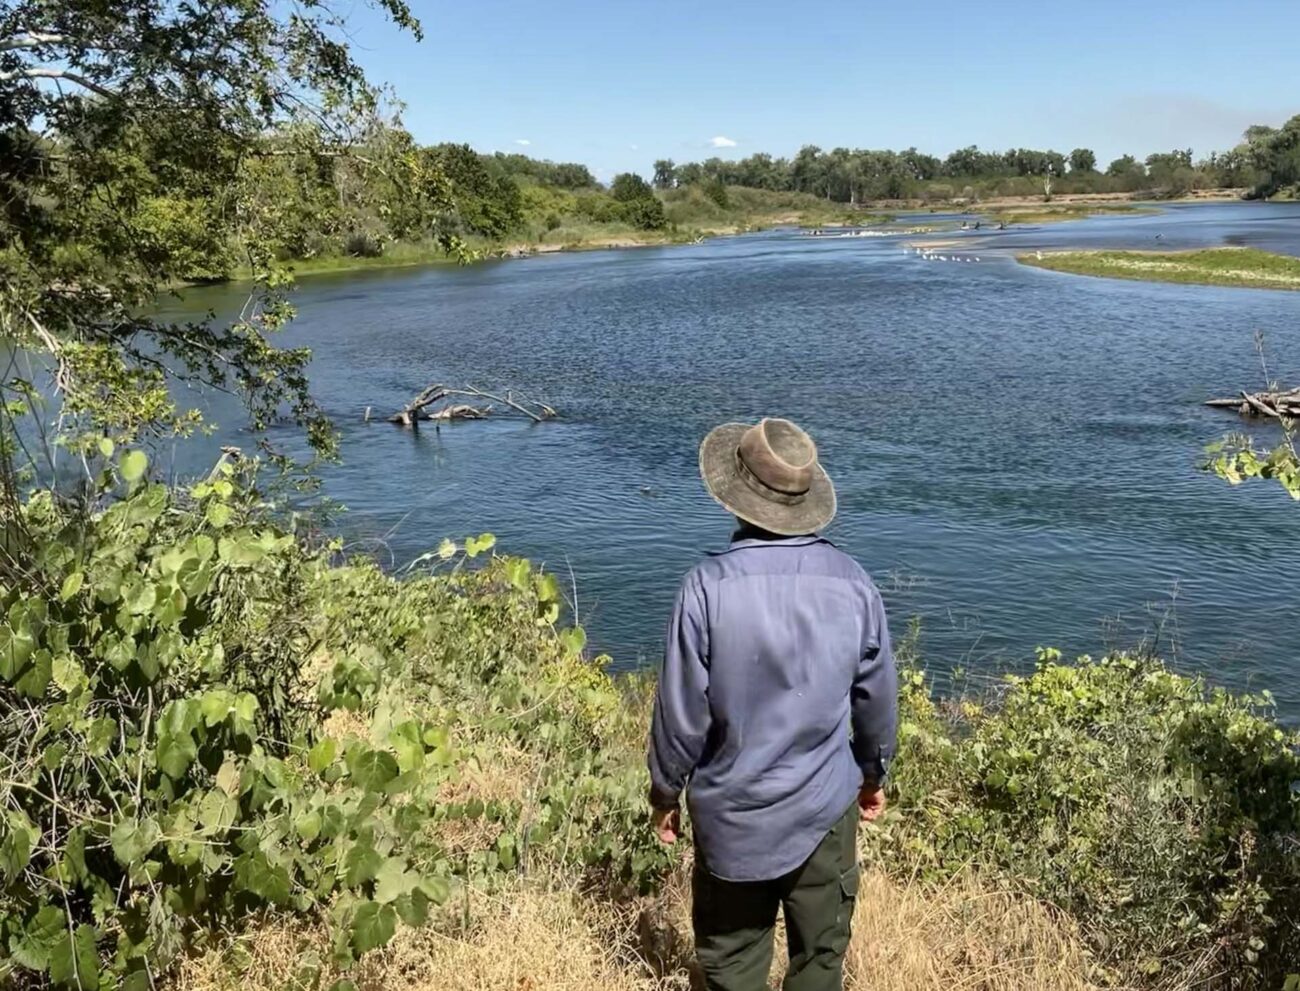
[1019,247,1300,289]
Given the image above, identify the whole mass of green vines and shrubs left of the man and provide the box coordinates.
[0,453,667,988]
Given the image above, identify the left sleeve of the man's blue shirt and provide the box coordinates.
[649,575,711,809]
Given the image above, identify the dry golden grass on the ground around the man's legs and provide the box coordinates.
[172,871,1107,991]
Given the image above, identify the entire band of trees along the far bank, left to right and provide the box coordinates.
[22,100,1300,278]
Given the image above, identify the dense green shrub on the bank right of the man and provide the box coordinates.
[878,650,1300,987]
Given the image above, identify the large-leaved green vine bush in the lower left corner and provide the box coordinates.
[0,453,462,988]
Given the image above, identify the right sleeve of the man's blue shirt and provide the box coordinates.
[850,587,898,786]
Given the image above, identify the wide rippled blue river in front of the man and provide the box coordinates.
[162,204,1300,720]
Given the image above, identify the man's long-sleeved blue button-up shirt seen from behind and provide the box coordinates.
[650,533,898,880]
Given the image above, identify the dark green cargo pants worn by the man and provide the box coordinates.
[692,802,858,991]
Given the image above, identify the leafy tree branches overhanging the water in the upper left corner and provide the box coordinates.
[0,0,450,450]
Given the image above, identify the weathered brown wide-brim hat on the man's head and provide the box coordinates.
[699,419,835,537]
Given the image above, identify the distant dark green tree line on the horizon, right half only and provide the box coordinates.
[653,116,1300,203]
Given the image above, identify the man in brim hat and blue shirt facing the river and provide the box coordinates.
[650,420,897,991]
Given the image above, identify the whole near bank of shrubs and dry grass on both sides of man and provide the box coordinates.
[0,456,1300,991]
